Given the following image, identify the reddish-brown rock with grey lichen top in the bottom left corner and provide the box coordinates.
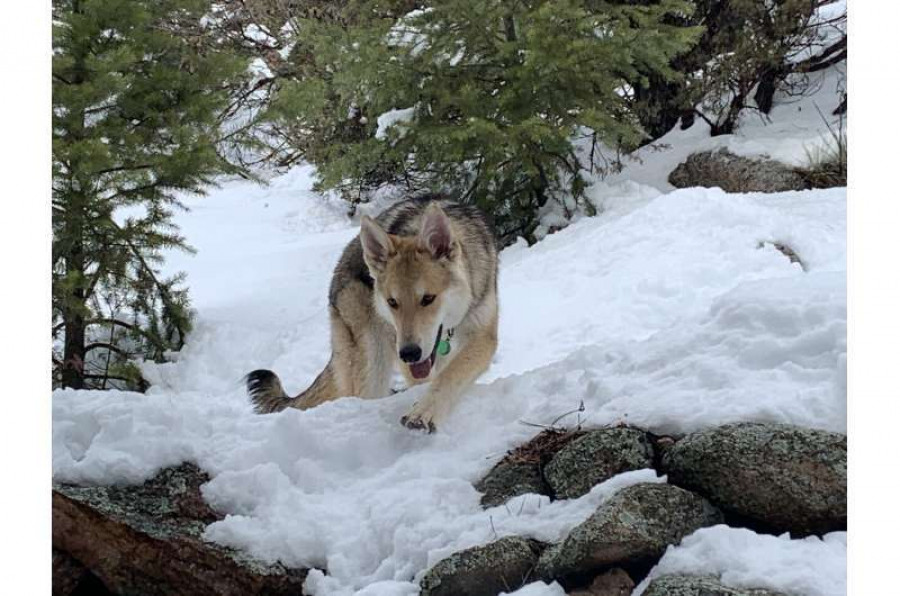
[53,464,306,596]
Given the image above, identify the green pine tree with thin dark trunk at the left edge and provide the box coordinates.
[52,0,245,388]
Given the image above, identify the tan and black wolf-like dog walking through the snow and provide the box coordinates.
[246,196,498,432]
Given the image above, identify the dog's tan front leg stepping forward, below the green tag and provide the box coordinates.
[400,330,497,432]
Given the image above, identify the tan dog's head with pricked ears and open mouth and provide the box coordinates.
[359,203,472,379]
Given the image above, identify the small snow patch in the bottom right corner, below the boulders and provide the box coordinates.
[634,526,847,596]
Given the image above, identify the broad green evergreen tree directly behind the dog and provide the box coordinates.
[267,0,698,239]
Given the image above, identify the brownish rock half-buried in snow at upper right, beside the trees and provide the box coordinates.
[669,149,808,192]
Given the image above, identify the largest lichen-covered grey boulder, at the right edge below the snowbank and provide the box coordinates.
[662,423,847,535]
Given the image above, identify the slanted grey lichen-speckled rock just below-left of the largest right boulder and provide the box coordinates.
[537,483,722,579]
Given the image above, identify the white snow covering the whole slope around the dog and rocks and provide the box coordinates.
[53,59,847,596]
